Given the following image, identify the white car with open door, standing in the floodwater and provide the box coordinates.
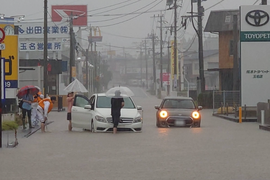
[71,93,143,132]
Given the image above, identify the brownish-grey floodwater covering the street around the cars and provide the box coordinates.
[0,89,270,180]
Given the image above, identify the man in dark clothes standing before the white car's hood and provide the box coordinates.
[111,91,125,134]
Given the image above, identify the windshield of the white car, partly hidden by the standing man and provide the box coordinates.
[97,96,135,109]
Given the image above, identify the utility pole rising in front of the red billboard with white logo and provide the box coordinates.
[69,12,75,83]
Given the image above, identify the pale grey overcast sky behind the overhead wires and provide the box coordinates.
[0,0,270,53]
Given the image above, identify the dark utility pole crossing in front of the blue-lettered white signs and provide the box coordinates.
[43,0,48,97]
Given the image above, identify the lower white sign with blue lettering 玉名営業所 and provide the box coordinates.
[19,41,62,51]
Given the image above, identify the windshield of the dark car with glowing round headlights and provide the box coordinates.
[162,99,195,109]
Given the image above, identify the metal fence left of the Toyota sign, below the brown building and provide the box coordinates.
[213,91,240,114]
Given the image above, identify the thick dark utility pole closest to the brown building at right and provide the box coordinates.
[197,0,205,93]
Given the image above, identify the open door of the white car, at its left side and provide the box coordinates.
[71,95,92,129]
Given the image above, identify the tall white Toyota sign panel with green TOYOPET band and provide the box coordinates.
[240,5,270,106]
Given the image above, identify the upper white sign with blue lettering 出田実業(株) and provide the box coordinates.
[15,22,69,38]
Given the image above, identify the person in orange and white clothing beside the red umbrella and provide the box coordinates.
[37,96,56,132]
